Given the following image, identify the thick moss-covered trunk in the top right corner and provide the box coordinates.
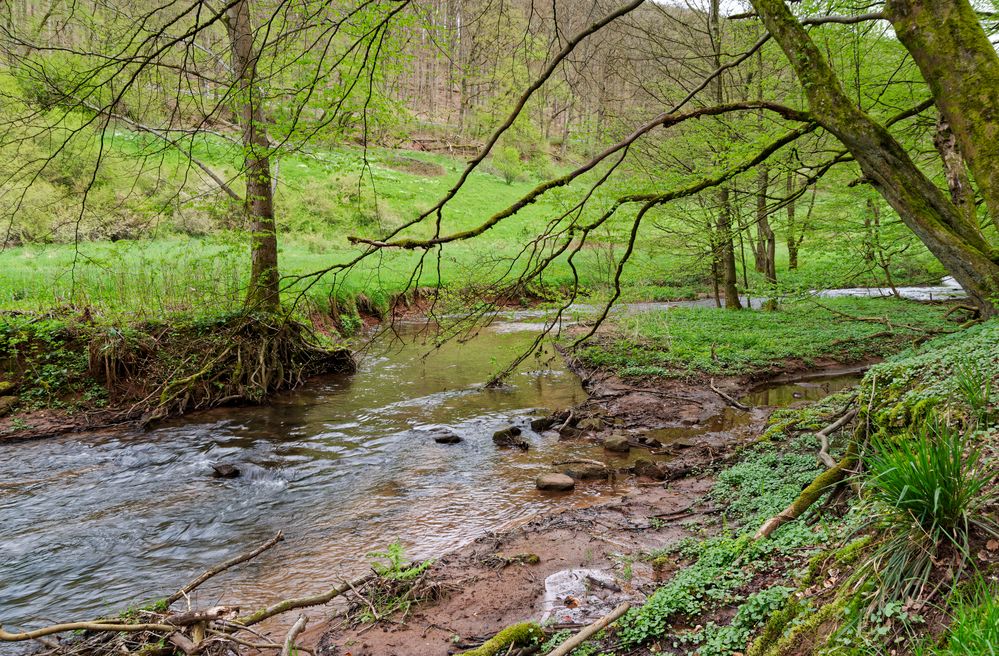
[885,0,999,236]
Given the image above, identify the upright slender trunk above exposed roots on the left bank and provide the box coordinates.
[226,0,281,312]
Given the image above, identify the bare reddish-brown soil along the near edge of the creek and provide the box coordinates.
[306,376,780,656]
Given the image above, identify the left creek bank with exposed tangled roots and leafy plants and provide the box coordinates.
[0,313,356,444]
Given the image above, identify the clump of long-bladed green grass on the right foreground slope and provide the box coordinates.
[863,419,995,606]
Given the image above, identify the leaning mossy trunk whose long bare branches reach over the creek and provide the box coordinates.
[752,0,999,317]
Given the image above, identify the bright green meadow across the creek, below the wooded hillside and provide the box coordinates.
[0,119,942,320]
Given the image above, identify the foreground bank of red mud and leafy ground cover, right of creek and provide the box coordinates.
[309,322,999,656]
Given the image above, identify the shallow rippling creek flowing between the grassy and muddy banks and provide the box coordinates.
[0,317,868,640]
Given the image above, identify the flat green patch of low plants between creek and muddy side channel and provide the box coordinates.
[581,298,956,376]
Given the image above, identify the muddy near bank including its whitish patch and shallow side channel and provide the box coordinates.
[309,367,860,656]
